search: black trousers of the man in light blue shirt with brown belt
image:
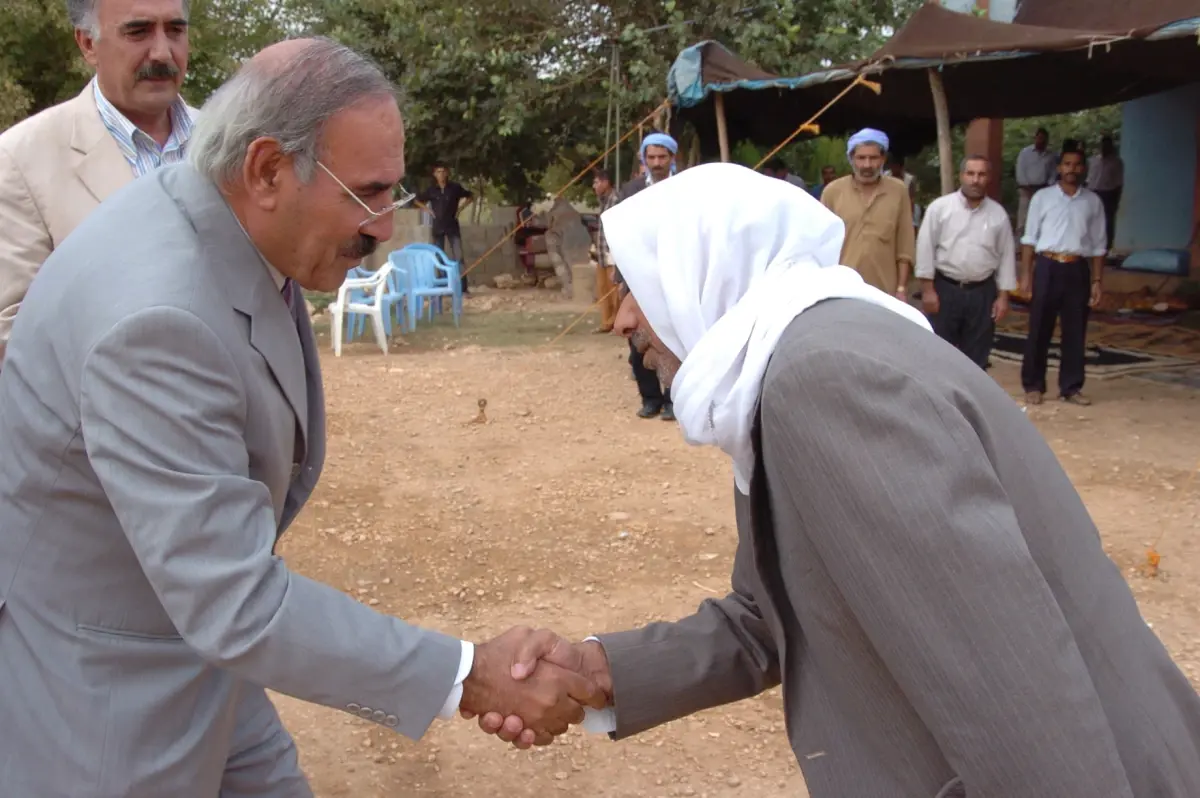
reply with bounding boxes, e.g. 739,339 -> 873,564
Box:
1021,256 -> 1092,396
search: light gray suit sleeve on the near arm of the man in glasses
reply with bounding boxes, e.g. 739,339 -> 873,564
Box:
79,308 -> 462,738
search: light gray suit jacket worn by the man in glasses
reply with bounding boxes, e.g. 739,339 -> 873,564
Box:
0,166 -> 461,798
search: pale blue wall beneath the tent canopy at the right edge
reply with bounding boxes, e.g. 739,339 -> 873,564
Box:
1114,84 -> 1200,256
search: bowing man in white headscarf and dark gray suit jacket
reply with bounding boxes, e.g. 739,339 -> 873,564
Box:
463,164 -> 1200,798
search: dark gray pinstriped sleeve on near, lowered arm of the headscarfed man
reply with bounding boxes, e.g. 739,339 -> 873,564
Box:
762,350 -> 1132,796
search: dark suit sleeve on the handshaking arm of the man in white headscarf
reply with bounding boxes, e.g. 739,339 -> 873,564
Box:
599,504 -> 779,739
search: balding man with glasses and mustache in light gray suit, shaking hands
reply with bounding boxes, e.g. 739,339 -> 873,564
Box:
0,40 -> 604,798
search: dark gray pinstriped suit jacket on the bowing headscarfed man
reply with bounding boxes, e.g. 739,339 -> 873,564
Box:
600,300 -> 1200,798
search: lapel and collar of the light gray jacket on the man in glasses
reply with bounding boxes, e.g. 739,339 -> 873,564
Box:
155,163 -> 311,448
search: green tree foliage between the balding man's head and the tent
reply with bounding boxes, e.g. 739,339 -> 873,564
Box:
312,0 -> 918,202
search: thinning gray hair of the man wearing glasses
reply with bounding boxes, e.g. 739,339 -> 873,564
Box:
187,37 -> 397,184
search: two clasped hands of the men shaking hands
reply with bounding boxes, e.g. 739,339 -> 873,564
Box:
458,626 -> 612,749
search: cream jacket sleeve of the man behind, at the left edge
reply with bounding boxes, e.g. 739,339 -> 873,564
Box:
0,149 -> 52,367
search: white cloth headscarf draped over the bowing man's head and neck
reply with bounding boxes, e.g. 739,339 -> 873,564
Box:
601,163 -> 929,493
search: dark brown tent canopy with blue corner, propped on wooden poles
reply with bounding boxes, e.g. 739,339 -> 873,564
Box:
667,0 -> 1200,157
